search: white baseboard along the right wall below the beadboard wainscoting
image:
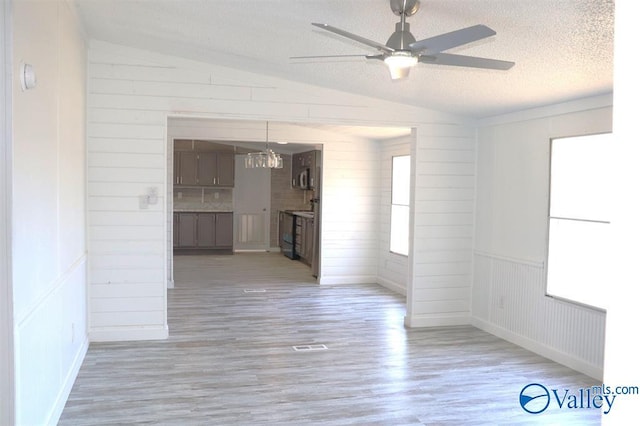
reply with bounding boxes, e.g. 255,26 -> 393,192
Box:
471,317 -> 604,381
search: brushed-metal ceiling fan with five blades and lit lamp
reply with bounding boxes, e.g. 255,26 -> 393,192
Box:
291,0 -> 515,80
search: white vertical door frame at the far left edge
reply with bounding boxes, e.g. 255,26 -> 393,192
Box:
0,0 -> 15,425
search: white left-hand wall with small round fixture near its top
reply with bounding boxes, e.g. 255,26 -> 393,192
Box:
11,0 -> 89,425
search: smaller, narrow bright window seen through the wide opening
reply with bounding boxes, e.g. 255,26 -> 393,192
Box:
389,155 -> 411,256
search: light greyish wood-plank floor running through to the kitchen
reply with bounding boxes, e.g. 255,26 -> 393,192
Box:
60,253 -> 600,425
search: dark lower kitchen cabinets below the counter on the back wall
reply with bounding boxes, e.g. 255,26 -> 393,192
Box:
173,212 -> 233,249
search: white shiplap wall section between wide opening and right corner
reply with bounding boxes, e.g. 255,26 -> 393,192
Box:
406,125 -> 476,326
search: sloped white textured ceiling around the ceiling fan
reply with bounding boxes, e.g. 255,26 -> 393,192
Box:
74,0 -> 614,118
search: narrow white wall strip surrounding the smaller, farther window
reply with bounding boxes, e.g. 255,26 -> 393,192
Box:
377,137 -> 411,295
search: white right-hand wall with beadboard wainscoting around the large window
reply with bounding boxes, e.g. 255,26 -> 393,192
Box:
472,96 -> 612,379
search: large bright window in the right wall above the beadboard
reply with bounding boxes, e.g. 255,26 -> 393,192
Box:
547,133 -> 612,307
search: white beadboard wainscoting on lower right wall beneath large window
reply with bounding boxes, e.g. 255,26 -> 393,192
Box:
473,253 -> 605,379
